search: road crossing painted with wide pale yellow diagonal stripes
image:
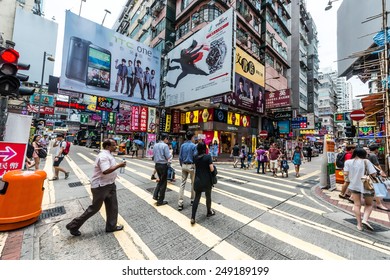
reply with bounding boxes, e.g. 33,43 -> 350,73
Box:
37,147 -> 390,260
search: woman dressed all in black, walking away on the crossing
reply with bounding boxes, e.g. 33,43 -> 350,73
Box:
191,142 -> 215,225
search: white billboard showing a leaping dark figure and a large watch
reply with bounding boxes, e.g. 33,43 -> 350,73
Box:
165,9 -> 235,106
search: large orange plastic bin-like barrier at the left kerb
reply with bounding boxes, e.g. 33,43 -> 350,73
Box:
0,170 -> 47,231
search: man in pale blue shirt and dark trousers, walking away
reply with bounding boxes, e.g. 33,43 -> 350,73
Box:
153,134 -> 170,206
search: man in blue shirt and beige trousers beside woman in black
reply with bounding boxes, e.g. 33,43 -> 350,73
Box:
177,131 -> 196,211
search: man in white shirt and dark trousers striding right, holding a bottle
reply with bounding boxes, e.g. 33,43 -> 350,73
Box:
66,139 -> 126,236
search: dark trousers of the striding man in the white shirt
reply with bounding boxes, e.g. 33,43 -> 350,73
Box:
68,183 -> 118,231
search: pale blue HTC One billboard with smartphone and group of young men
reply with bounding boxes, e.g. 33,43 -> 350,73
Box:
60,11 -> 161,105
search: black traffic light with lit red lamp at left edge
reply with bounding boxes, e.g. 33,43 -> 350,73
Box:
0,47 -> 20,96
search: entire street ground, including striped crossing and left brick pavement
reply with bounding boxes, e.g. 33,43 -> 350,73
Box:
0,146 -> 390,260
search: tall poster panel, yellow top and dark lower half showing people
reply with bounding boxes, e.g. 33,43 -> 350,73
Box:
222,47 -> 265,114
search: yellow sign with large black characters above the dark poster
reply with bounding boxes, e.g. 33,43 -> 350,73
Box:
236,47 -> 264,87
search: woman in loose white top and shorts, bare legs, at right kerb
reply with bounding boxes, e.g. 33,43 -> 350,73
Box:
344,148 -> 376,231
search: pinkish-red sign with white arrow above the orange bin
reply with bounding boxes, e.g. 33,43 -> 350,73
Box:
0,142 -> 27,176
